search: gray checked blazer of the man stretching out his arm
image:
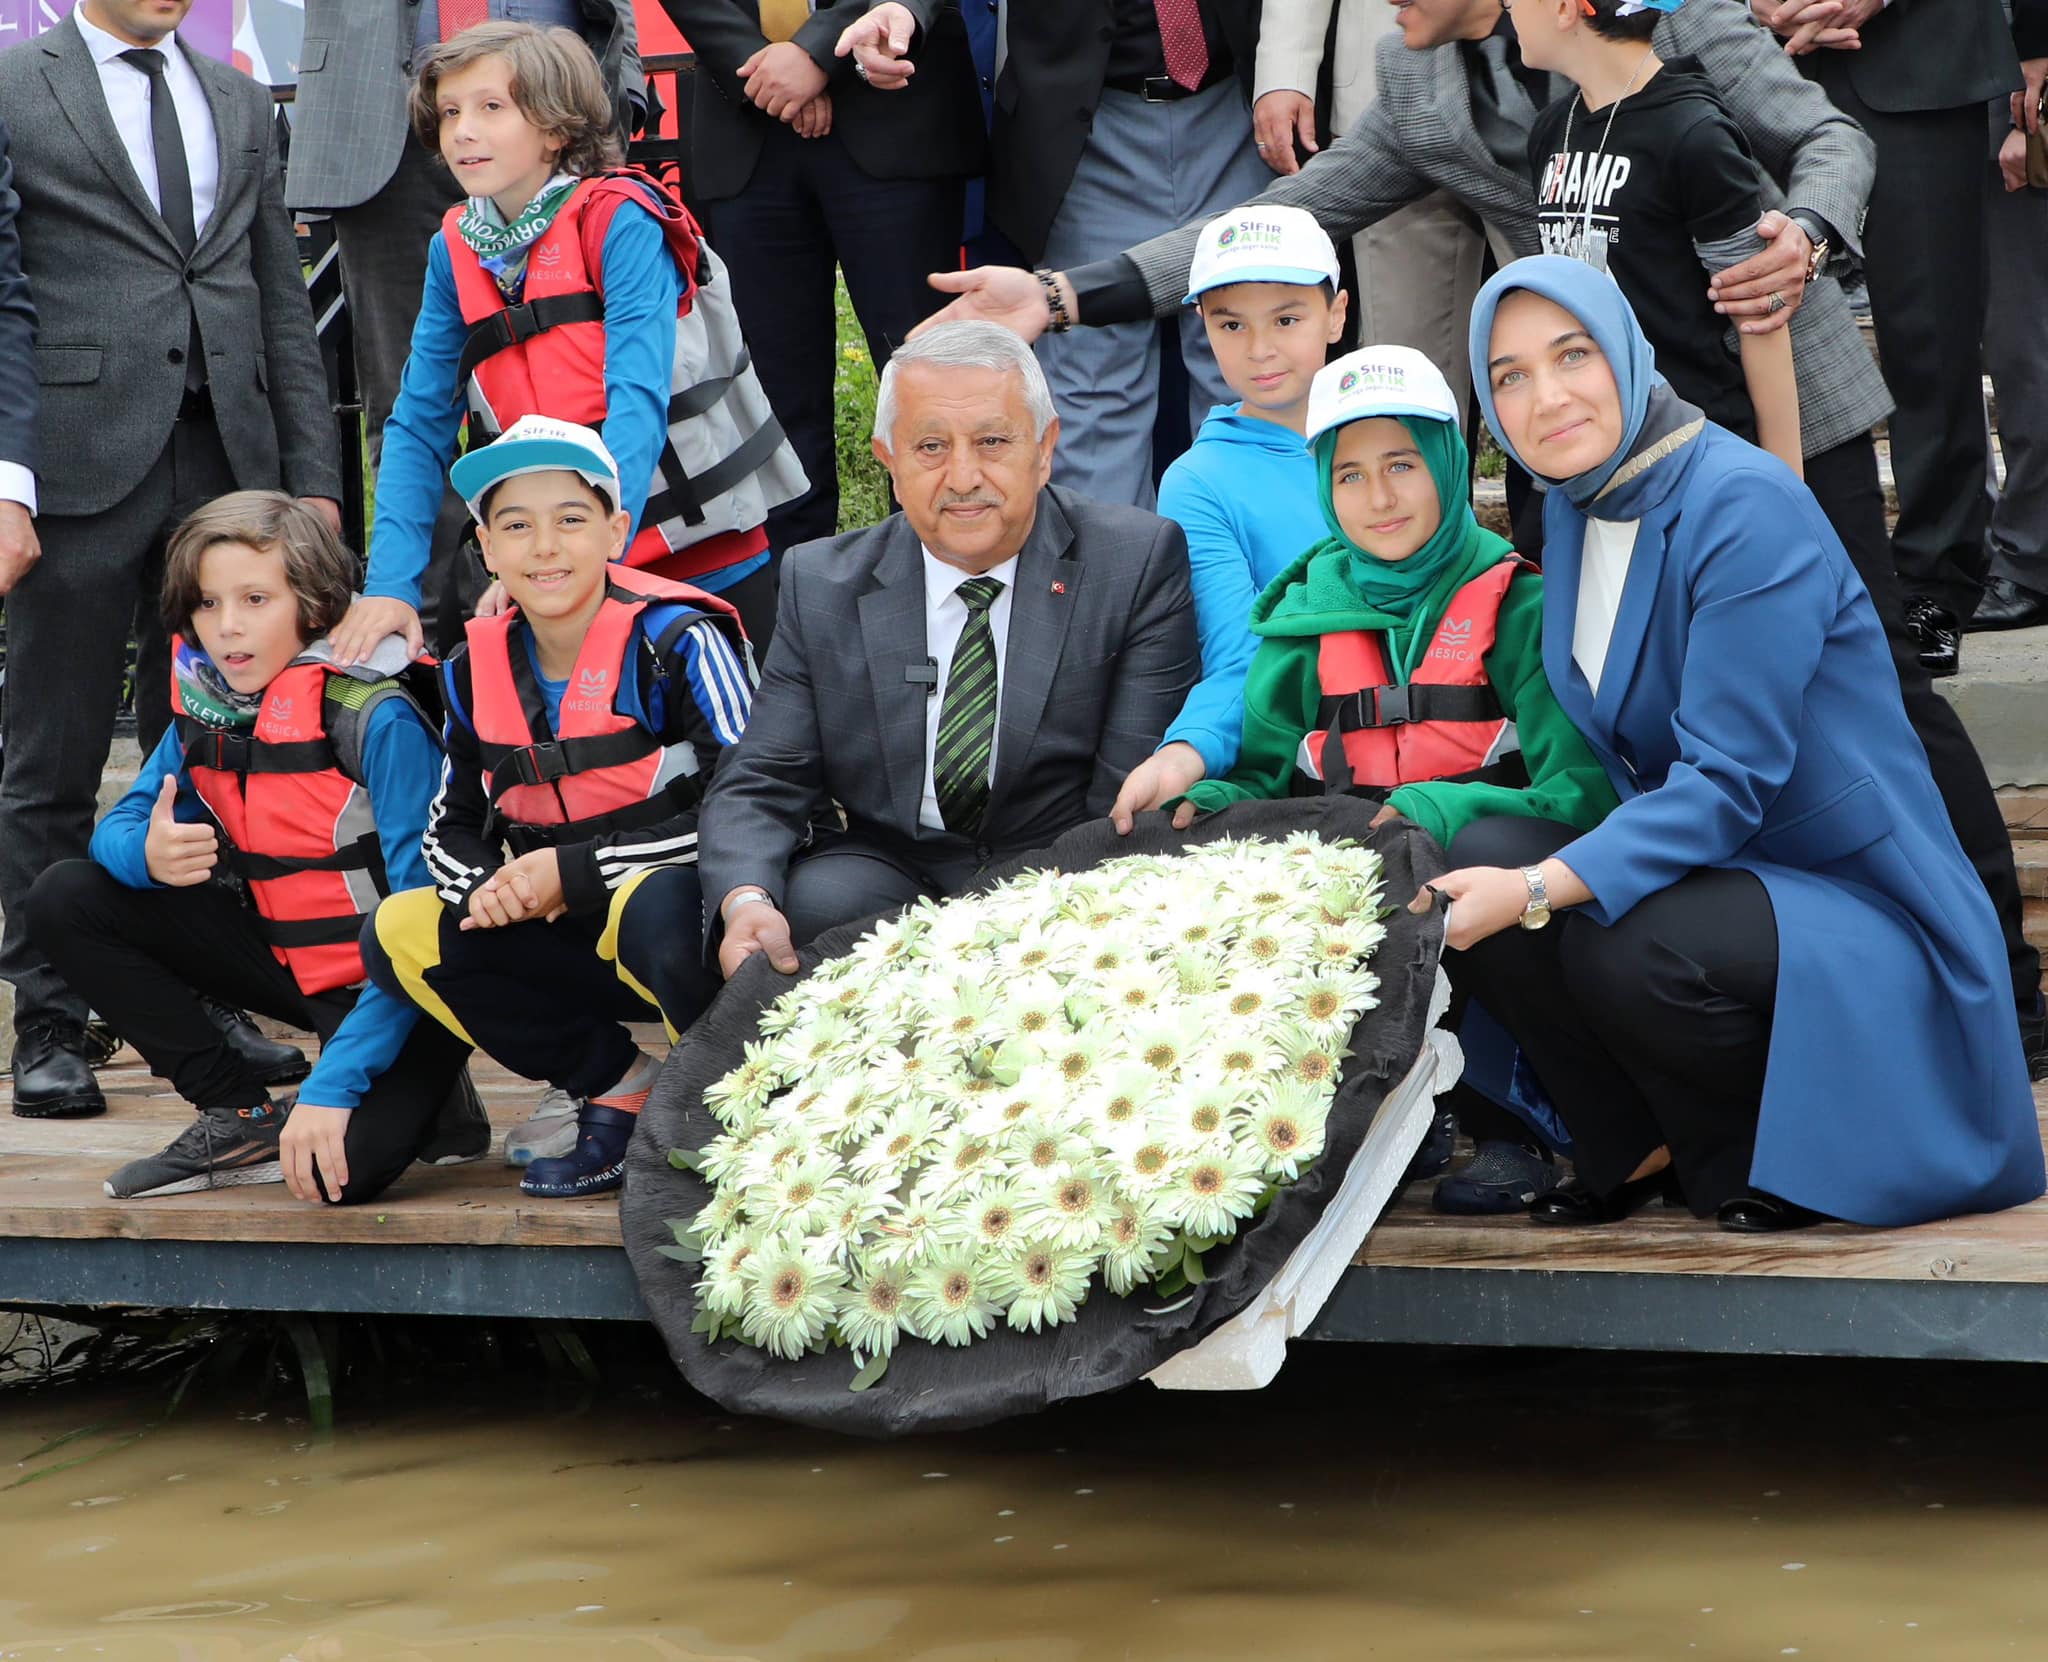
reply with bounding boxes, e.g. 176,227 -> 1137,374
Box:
1122,0 -> 1892,454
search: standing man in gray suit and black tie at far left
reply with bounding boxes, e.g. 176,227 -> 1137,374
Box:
0,0 -> 340,1116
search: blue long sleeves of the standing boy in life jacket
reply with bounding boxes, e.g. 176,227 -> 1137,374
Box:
362,203 -> 684,608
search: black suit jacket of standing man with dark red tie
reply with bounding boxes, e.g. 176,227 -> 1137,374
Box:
995,0 -> 1261,260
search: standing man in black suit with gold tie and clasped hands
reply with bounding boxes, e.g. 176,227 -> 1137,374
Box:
662,0 -> 985,551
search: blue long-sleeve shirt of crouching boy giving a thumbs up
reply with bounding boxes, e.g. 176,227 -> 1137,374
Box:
92,698 -> 440,1107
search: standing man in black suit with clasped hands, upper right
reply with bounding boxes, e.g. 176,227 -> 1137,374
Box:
1751,0 -> 2019,675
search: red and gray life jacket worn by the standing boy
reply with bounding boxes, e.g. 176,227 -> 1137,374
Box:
442,170 -> 809,577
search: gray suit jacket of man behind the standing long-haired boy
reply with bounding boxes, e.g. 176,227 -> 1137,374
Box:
285,0 -> 630,209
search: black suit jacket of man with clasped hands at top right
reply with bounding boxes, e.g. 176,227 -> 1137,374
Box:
1800,0 -> 2019,113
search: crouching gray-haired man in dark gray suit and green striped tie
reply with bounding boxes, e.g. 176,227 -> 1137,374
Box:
696,323 -> 1198,974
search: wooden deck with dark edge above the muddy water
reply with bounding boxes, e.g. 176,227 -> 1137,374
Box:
0,1052 -> 2048,1361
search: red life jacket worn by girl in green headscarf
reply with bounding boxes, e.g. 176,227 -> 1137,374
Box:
1294,559 -> 1532,796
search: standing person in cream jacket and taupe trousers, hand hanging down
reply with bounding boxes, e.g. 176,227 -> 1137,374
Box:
1251,0 -> 1487,418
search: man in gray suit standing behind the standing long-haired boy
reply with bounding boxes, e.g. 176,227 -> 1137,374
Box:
285,0 -> 630,463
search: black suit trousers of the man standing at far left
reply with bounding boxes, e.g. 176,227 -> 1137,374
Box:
0,403 -> 236,1030
